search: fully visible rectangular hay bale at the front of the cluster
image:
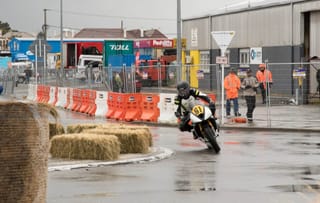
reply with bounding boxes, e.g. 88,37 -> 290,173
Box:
50,133 -> 120,160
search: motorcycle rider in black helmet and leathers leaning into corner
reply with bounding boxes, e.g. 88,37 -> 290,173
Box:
175,81 -> 218,139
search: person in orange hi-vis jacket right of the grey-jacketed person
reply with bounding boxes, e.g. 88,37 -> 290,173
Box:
256,63 -> 273,104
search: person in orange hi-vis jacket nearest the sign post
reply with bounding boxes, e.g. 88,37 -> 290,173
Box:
224,68 -> 241,117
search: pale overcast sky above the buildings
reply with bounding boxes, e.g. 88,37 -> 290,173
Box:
0,0 -> 245,37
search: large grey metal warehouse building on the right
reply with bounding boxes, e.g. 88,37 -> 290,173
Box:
182,0 -> 320,101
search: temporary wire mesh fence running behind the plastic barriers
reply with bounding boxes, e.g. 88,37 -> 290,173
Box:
1,62 -> 320,127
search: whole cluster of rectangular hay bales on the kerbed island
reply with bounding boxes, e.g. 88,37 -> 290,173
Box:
50,124 -> 153,160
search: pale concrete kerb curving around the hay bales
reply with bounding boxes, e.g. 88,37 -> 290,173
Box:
48,147 -> 174,172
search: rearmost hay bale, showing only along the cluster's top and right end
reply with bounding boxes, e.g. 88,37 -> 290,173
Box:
97,124 -> 153,147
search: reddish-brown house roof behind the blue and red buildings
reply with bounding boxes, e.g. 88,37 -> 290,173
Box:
74,28 -> 167,39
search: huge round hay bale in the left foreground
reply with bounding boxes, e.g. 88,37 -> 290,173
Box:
0,100 -> 58,203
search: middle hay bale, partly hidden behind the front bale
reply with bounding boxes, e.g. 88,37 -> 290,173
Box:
84,128 -> 150,154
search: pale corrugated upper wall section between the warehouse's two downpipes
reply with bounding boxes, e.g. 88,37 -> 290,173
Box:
212,6 -> 291,48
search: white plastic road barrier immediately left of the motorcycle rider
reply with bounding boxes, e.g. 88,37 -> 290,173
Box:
158,93 -> 177,124
